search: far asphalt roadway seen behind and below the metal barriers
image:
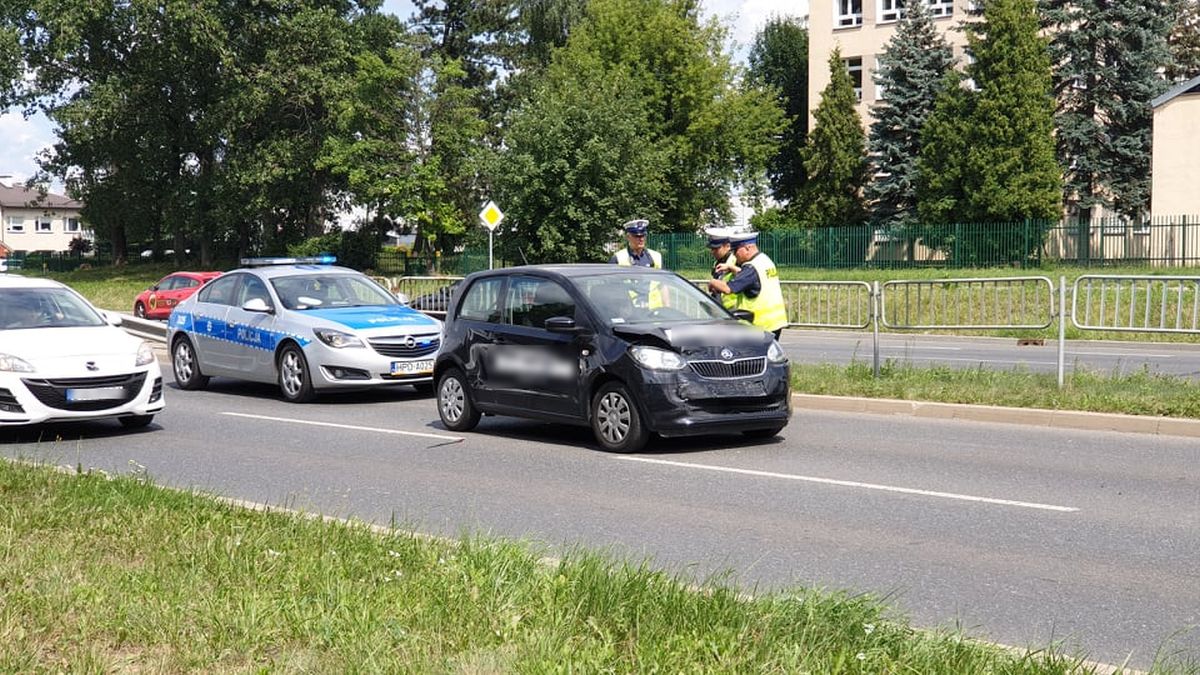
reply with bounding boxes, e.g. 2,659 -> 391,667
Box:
781,329 -> 1200,378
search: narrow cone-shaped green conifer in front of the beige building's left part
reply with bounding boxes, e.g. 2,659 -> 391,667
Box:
803,48 -> 868,226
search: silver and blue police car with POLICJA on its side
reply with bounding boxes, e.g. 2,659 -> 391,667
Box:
167,256 -> 442,402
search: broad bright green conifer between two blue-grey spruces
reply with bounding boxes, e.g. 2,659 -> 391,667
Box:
918,0 -> 1062,222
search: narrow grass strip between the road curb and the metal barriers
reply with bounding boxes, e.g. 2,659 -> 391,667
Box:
792,360 -> 1200,419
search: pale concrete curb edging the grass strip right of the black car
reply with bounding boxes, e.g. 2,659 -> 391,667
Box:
792,394 -> 1200,438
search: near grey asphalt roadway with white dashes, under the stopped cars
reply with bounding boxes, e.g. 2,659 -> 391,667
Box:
0,367 -> 1200,667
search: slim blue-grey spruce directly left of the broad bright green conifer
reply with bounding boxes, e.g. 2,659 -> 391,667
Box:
866,0 -> 954,228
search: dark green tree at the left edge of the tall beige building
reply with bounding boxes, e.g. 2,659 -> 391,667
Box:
749,17 -> 809,204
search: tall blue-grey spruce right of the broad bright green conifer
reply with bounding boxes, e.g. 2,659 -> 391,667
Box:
1042,0 -> 1176,216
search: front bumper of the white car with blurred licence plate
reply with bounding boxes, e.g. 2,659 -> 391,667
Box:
0,364 -> 164,426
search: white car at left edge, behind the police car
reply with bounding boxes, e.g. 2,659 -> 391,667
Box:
0,274 -> 164,428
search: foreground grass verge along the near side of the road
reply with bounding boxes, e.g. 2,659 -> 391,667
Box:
0,461 -> 1180,675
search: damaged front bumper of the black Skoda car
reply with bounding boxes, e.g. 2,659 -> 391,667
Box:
643,364 -> 792,437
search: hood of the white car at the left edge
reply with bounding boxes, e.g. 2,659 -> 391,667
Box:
0,325 -> 142,377
